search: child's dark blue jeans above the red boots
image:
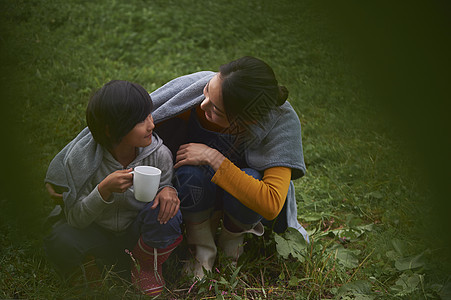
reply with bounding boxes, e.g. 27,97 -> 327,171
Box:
44,202 -> 182,278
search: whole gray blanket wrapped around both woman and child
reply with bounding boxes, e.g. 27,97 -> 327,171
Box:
45,71 -> 308,240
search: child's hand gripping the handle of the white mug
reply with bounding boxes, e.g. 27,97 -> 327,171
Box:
98,169 -> 133,201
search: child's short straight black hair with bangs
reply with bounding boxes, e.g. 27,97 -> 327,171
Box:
86,80 -> 153,149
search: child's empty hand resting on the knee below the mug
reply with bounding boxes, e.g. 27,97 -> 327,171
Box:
150,186 -> 180,224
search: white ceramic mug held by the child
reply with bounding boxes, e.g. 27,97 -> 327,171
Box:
130,166 -> 161,202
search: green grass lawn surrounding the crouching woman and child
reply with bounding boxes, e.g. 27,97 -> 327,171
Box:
0,0 -> 451,299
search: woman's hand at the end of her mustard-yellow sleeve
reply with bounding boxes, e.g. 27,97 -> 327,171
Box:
174,143 -> 225,171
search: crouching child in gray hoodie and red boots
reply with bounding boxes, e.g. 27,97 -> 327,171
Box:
44,80 -> 182,295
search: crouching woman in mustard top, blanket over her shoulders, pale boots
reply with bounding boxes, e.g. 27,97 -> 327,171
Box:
151,57 -> 308,278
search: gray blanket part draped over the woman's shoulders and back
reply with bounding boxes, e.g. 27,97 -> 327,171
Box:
150,71 -> 308,241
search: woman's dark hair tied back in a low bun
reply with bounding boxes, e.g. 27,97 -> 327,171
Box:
219,56 -> 288,122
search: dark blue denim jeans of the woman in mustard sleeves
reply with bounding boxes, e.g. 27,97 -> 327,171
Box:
174,166 -> 263,230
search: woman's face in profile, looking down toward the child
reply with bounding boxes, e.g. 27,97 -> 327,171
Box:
200,73 -> 230,128
